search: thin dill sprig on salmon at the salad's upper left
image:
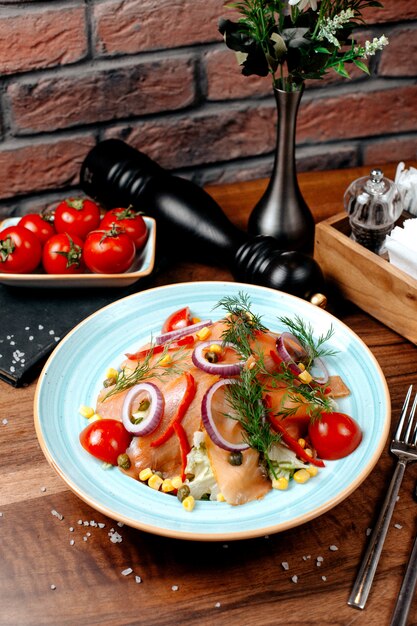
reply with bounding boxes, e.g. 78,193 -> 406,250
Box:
104,344 -> 184,400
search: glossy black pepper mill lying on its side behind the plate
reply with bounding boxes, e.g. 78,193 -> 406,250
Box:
80,139 -> 326,306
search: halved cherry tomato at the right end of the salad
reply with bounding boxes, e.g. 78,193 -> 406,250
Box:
308,412 -> 362,461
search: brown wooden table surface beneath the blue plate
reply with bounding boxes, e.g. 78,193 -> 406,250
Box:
0,167 -> 417,626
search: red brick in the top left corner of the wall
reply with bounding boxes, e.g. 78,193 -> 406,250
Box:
0,6 -> 87,74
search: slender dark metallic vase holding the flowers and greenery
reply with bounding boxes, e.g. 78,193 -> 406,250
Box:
248,89 -> 314,254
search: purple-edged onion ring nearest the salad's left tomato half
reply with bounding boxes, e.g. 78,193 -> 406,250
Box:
122,383 -> 165,436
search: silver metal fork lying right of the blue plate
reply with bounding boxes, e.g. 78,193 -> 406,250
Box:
348,385 -> 417,609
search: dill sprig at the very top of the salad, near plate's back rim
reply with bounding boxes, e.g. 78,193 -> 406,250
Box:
214,291 -> 267,359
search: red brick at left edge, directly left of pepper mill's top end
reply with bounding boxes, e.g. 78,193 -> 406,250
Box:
0,136 -> 95,199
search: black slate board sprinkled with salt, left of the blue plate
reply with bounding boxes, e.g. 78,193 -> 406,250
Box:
0,277 -> 154,387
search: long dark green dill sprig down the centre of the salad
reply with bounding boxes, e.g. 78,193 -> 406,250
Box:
226,367 -> 281,477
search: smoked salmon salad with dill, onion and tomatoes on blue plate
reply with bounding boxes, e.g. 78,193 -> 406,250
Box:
80,292 -> 362,511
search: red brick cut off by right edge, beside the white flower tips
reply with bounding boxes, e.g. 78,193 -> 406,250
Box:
378,26 -> 417,76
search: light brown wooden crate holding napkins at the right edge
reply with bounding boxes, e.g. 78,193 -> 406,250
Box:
315,213 -> 417,344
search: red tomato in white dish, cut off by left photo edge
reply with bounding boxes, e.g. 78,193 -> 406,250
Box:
0,224 -> 42,274
